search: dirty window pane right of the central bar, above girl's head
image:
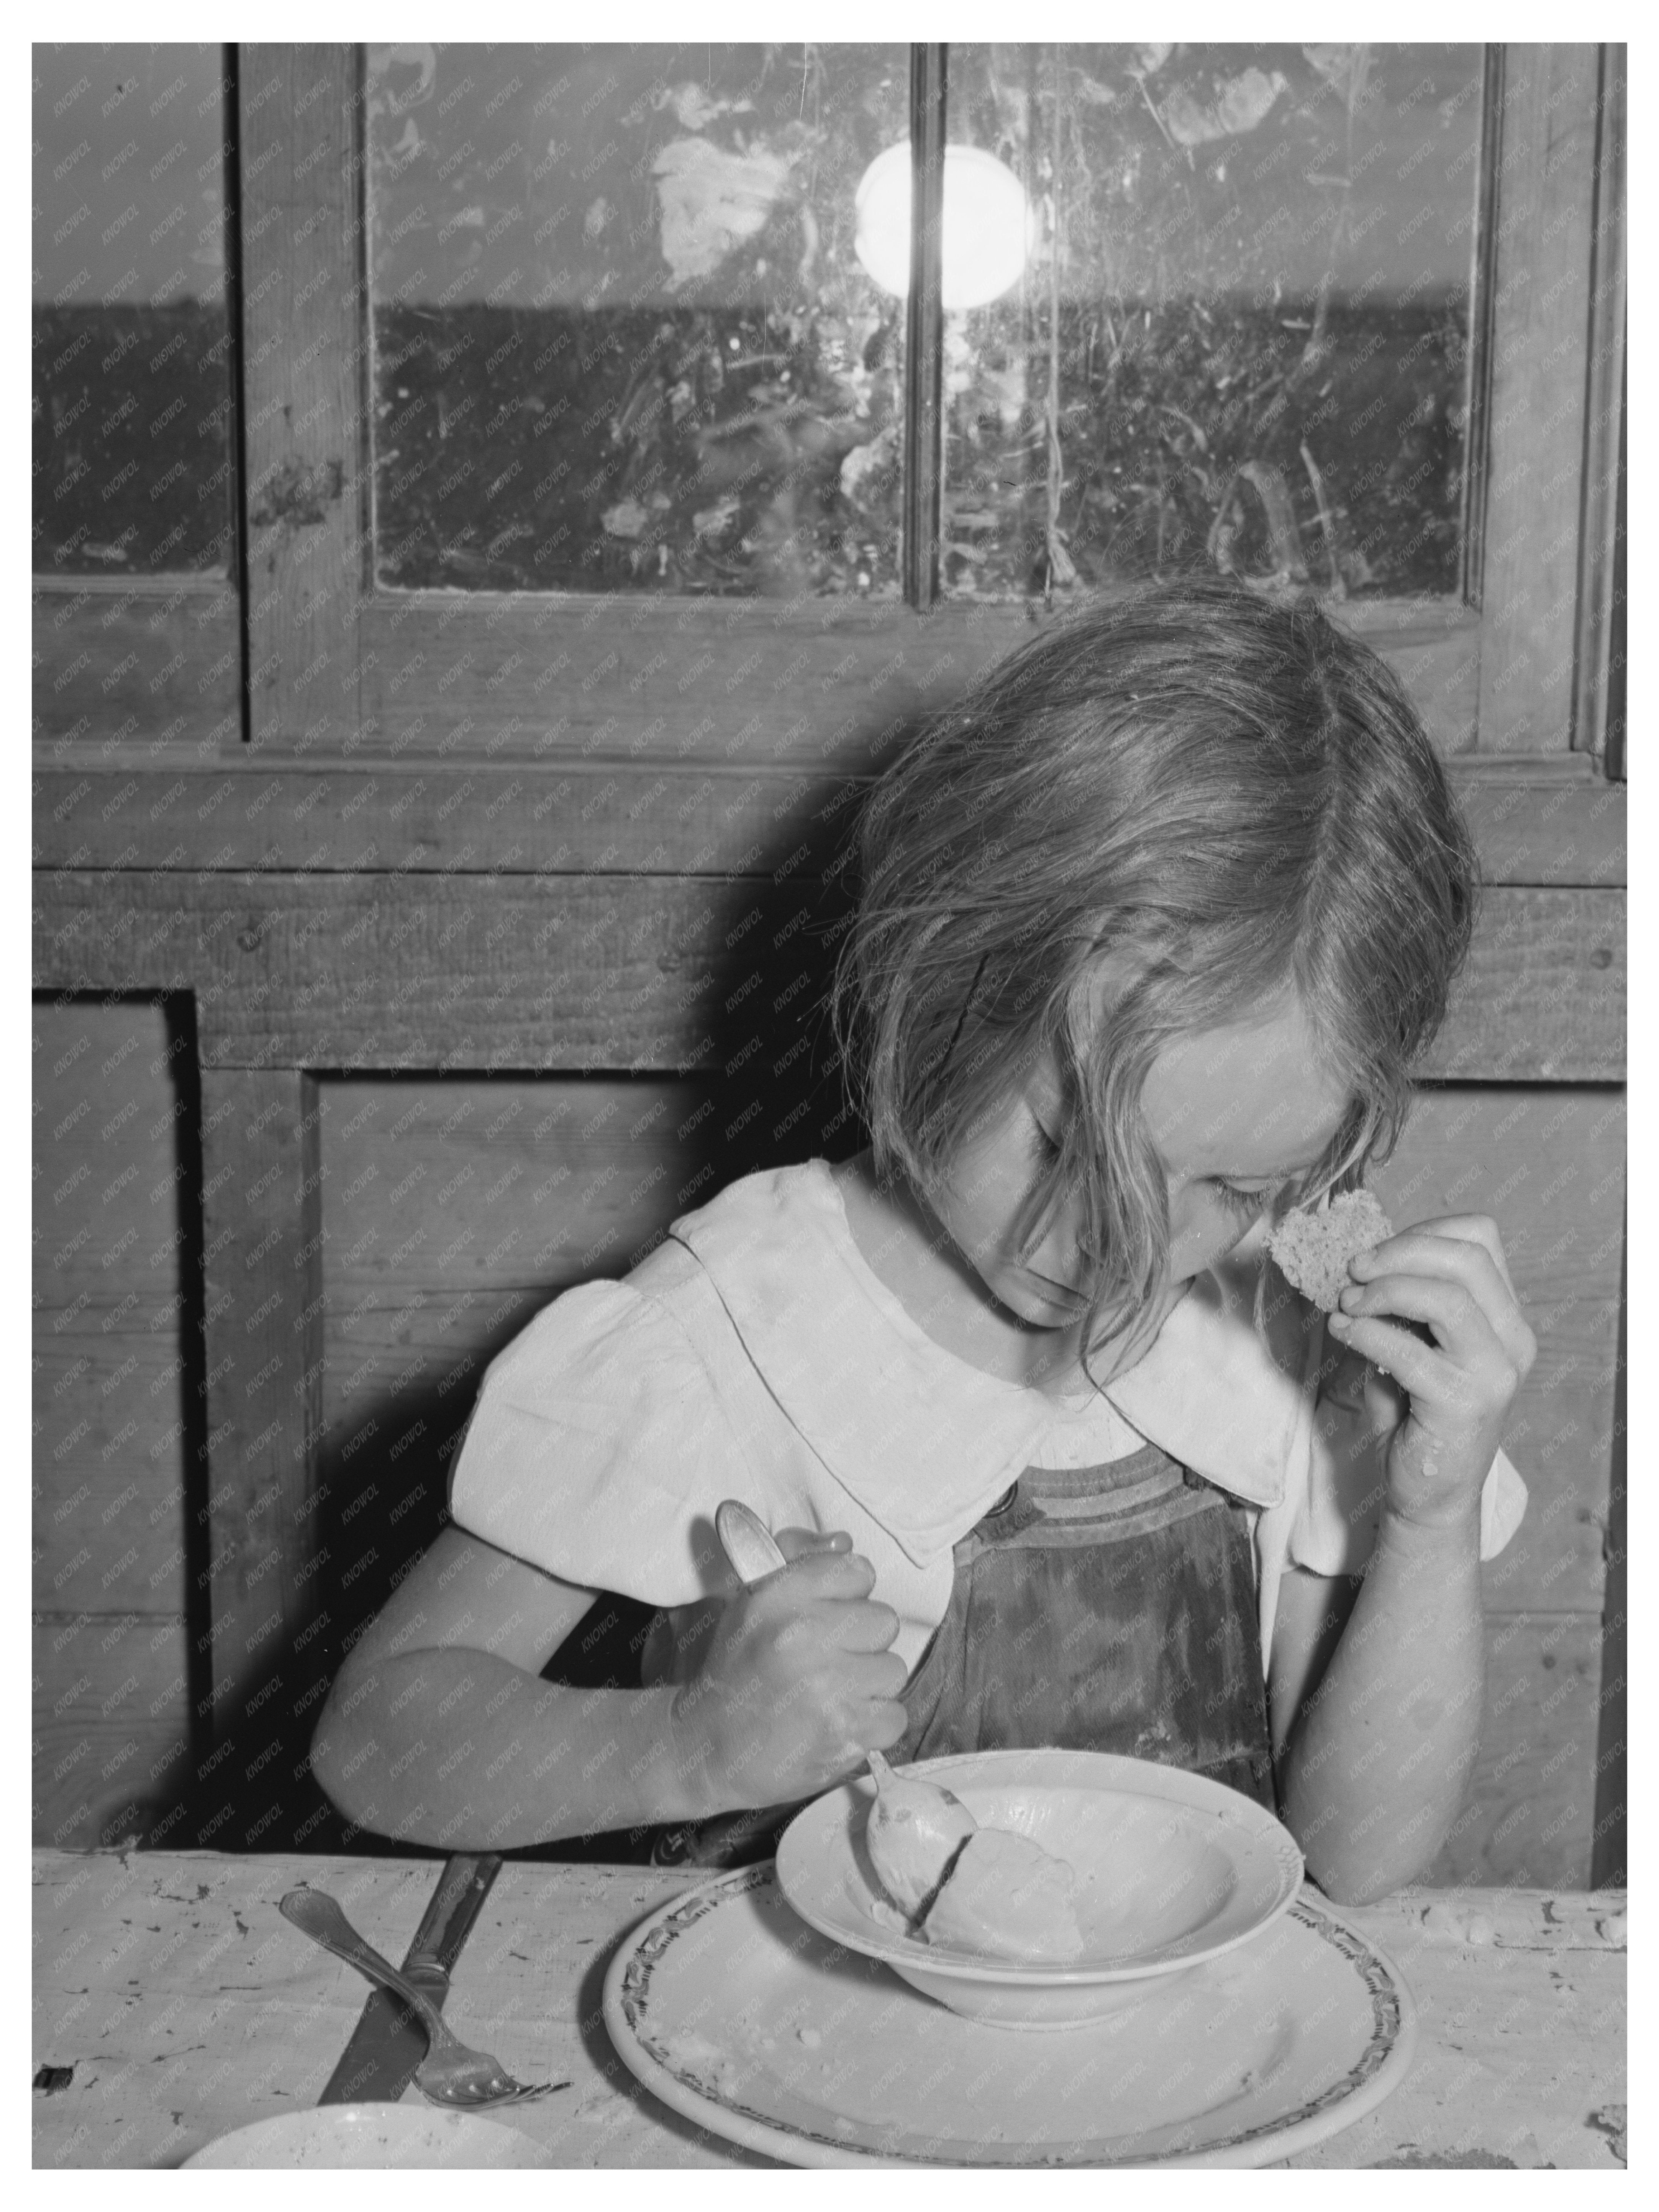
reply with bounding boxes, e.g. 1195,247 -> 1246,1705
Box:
940,44 -> 1482,597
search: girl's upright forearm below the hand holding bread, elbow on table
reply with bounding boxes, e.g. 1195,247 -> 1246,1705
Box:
1281,1511 -> 1487,1905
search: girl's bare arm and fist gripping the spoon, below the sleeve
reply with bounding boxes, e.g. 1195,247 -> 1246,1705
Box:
312,1528 -> 905,1851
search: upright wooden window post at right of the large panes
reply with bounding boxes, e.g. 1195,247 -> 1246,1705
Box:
1478,44 -> 1597,752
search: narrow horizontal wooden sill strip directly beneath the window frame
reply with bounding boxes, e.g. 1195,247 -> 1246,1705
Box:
33,741 -> 1626,887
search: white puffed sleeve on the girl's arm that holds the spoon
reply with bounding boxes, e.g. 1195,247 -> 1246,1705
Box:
449,1281 -> 741,1606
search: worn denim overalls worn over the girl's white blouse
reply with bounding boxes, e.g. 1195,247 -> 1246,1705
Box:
652,1445 -> 1279,1867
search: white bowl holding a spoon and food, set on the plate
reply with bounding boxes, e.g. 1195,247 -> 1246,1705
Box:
776,1748 -> 1303,2028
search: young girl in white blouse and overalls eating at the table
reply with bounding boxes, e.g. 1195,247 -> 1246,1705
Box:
314,584 -> 1535,1900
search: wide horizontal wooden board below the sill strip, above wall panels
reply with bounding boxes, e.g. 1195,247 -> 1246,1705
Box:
35,869 -> 1624,1082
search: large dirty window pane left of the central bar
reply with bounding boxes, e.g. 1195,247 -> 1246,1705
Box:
367,44 -> 909,593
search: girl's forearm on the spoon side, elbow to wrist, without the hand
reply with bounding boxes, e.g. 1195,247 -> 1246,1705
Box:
312,1646 -> 719,1851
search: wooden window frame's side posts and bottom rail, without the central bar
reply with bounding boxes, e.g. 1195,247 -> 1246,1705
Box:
33,44 -> 1624,787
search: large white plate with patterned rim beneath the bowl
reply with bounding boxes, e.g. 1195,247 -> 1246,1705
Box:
604,1865 -> 1413,2166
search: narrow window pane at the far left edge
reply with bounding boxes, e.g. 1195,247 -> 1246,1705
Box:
33,46 -> 234,575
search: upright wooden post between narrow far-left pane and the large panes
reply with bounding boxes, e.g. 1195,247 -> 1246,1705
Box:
239,44 -> 367,750
